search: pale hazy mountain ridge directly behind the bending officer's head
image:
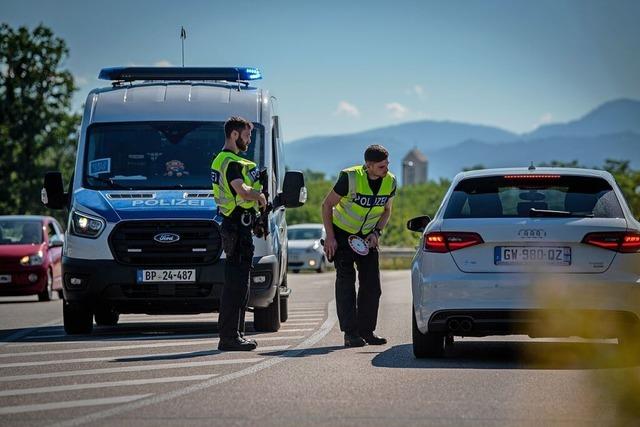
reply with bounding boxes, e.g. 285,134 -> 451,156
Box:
285,120 -> 518,176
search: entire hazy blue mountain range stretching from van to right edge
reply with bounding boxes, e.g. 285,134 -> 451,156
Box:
285,99 -> 640,179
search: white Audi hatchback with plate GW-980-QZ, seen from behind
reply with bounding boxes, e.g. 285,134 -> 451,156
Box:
407,167 -> 640,357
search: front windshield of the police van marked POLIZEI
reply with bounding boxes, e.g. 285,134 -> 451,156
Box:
83,122 -> 264,190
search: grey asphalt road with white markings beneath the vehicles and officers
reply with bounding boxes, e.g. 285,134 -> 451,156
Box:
0,271 -> 640,427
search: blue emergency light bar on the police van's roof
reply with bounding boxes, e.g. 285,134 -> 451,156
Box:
98,67 -> 262,82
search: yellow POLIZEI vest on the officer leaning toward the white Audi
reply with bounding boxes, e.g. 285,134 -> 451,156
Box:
333,165 -> 396,236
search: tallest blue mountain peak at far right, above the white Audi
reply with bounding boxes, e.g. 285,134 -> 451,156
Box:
523,99 -> 640,139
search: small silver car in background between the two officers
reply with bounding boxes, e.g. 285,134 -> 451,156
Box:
287,224 -> 330,273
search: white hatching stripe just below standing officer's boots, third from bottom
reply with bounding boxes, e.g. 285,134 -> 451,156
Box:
0,357 -> 263,382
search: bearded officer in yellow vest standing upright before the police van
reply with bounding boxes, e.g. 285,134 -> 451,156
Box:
211,117 -> 267,351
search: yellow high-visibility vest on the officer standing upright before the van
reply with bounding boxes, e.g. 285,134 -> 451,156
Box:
211,151 -> 262,216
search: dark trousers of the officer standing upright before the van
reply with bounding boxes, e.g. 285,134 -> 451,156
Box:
218,218 -> 254,339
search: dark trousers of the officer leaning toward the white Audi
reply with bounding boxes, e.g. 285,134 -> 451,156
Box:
334,244 -> 382,336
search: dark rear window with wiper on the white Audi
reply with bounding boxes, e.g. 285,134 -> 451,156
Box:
444,175 -> 624,218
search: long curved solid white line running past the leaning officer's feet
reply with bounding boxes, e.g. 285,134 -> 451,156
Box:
52,300 -> 338,427
